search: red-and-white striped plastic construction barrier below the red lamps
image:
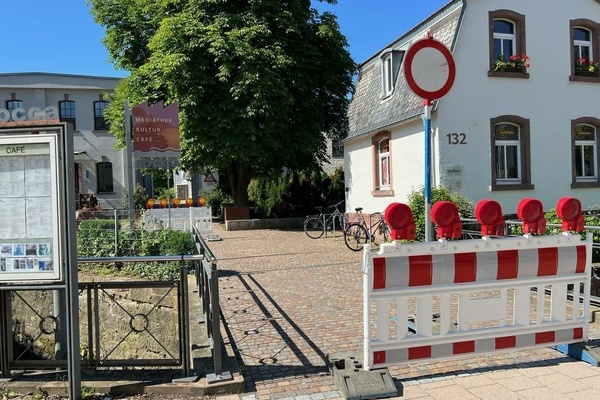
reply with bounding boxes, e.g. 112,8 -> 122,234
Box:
363,198 -> 592,370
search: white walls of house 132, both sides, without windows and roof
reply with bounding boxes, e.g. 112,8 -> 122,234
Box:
344,0 -> 600,214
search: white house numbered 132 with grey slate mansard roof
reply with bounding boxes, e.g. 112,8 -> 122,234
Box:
344,0 -> 600,219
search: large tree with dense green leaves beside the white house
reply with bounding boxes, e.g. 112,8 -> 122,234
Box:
88,0 -> 356,205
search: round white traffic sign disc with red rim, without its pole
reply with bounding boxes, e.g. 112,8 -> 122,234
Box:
404,38 -> 456,101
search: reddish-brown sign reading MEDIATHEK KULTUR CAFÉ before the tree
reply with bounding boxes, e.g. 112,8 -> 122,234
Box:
132,101 -> 180,153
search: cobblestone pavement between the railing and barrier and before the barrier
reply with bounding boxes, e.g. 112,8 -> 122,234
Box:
209,224 -> 600,400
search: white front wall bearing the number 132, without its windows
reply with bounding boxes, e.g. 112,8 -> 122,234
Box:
434,0 -> 600,213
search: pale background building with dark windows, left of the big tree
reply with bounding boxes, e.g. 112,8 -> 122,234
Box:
0,72 -> 218,208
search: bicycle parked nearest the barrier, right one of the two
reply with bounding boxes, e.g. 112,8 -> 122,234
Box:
344,207 -> 390,251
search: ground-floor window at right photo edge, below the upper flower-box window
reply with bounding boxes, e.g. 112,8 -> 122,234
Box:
571,117 -> 600,188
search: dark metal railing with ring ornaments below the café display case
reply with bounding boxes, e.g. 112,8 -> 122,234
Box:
0,228 -> 231,383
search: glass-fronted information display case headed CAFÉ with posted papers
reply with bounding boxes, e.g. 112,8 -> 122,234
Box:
0,132 -> 66,282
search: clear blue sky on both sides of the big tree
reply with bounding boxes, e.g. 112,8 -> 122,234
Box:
0,0 -> 450,77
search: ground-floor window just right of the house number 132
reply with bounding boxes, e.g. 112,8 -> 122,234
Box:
490,115 -> 533,190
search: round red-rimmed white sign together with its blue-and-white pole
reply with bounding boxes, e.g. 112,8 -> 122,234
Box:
404,33 -> 456,241
